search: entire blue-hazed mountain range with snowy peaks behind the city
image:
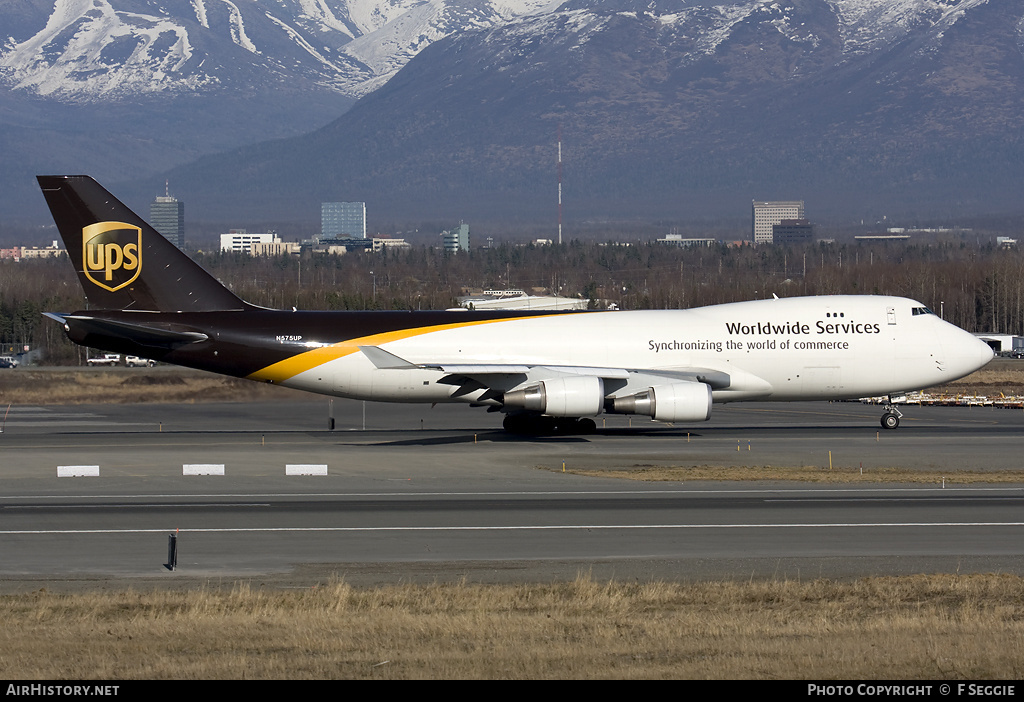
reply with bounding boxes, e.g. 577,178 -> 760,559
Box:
0,0 -> 1024,225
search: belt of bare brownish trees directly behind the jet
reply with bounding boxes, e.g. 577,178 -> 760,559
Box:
0,240 -> 1024,364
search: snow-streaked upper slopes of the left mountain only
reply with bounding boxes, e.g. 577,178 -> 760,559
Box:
0,0 -> 551,101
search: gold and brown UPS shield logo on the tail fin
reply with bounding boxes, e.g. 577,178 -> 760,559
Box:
82,222 -> 142,293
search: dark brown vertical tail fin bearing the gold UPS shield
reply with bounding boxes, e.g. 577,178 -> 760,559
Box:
37,176 -> 247,312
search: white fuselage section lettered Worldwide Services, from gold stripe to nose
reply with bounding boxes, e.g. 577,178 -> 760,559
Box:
283,296 -> 992,413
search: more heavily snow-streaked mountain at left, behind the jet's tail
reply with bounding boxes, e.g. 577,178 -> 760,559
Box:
0,0 -> 557,223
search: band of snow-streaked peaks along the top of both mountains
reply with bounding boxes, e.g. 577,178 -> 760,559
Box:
0,0 -> 988,101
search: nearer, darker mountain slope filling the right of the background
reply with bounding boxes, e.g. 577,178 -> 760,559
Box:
149,0 -> 1024,224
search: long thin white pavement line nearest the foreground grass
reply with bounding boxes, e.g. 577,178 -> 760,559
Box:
0,522 -> 1024,536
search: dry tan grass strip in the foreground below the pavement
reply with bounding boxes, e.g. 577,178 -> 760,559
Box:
0,575 -> 1024,679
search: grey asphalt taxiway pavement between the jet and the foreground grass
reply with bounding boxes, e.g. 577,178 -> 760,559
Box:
0,398 -> 1024,590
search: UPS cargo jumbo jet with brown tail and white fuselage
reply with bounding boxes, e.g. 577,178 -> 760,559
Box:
37,176 -> 993,434
